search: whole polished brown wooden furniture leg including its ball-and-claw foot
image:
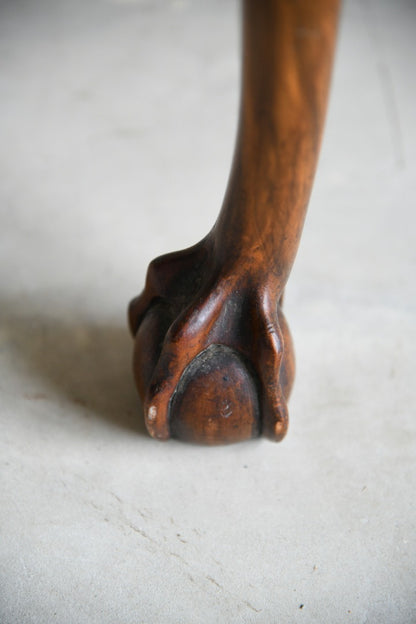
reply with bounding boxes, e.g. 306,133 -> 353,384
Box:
129,0 -> 339,444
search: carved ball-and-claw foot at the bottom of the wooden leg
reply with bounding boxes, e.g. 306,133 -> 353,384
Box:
129,237 -> 294,444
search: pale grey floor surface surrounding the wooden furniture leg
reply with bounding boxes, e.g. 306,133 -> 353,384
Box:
0,0 -> 416,624
